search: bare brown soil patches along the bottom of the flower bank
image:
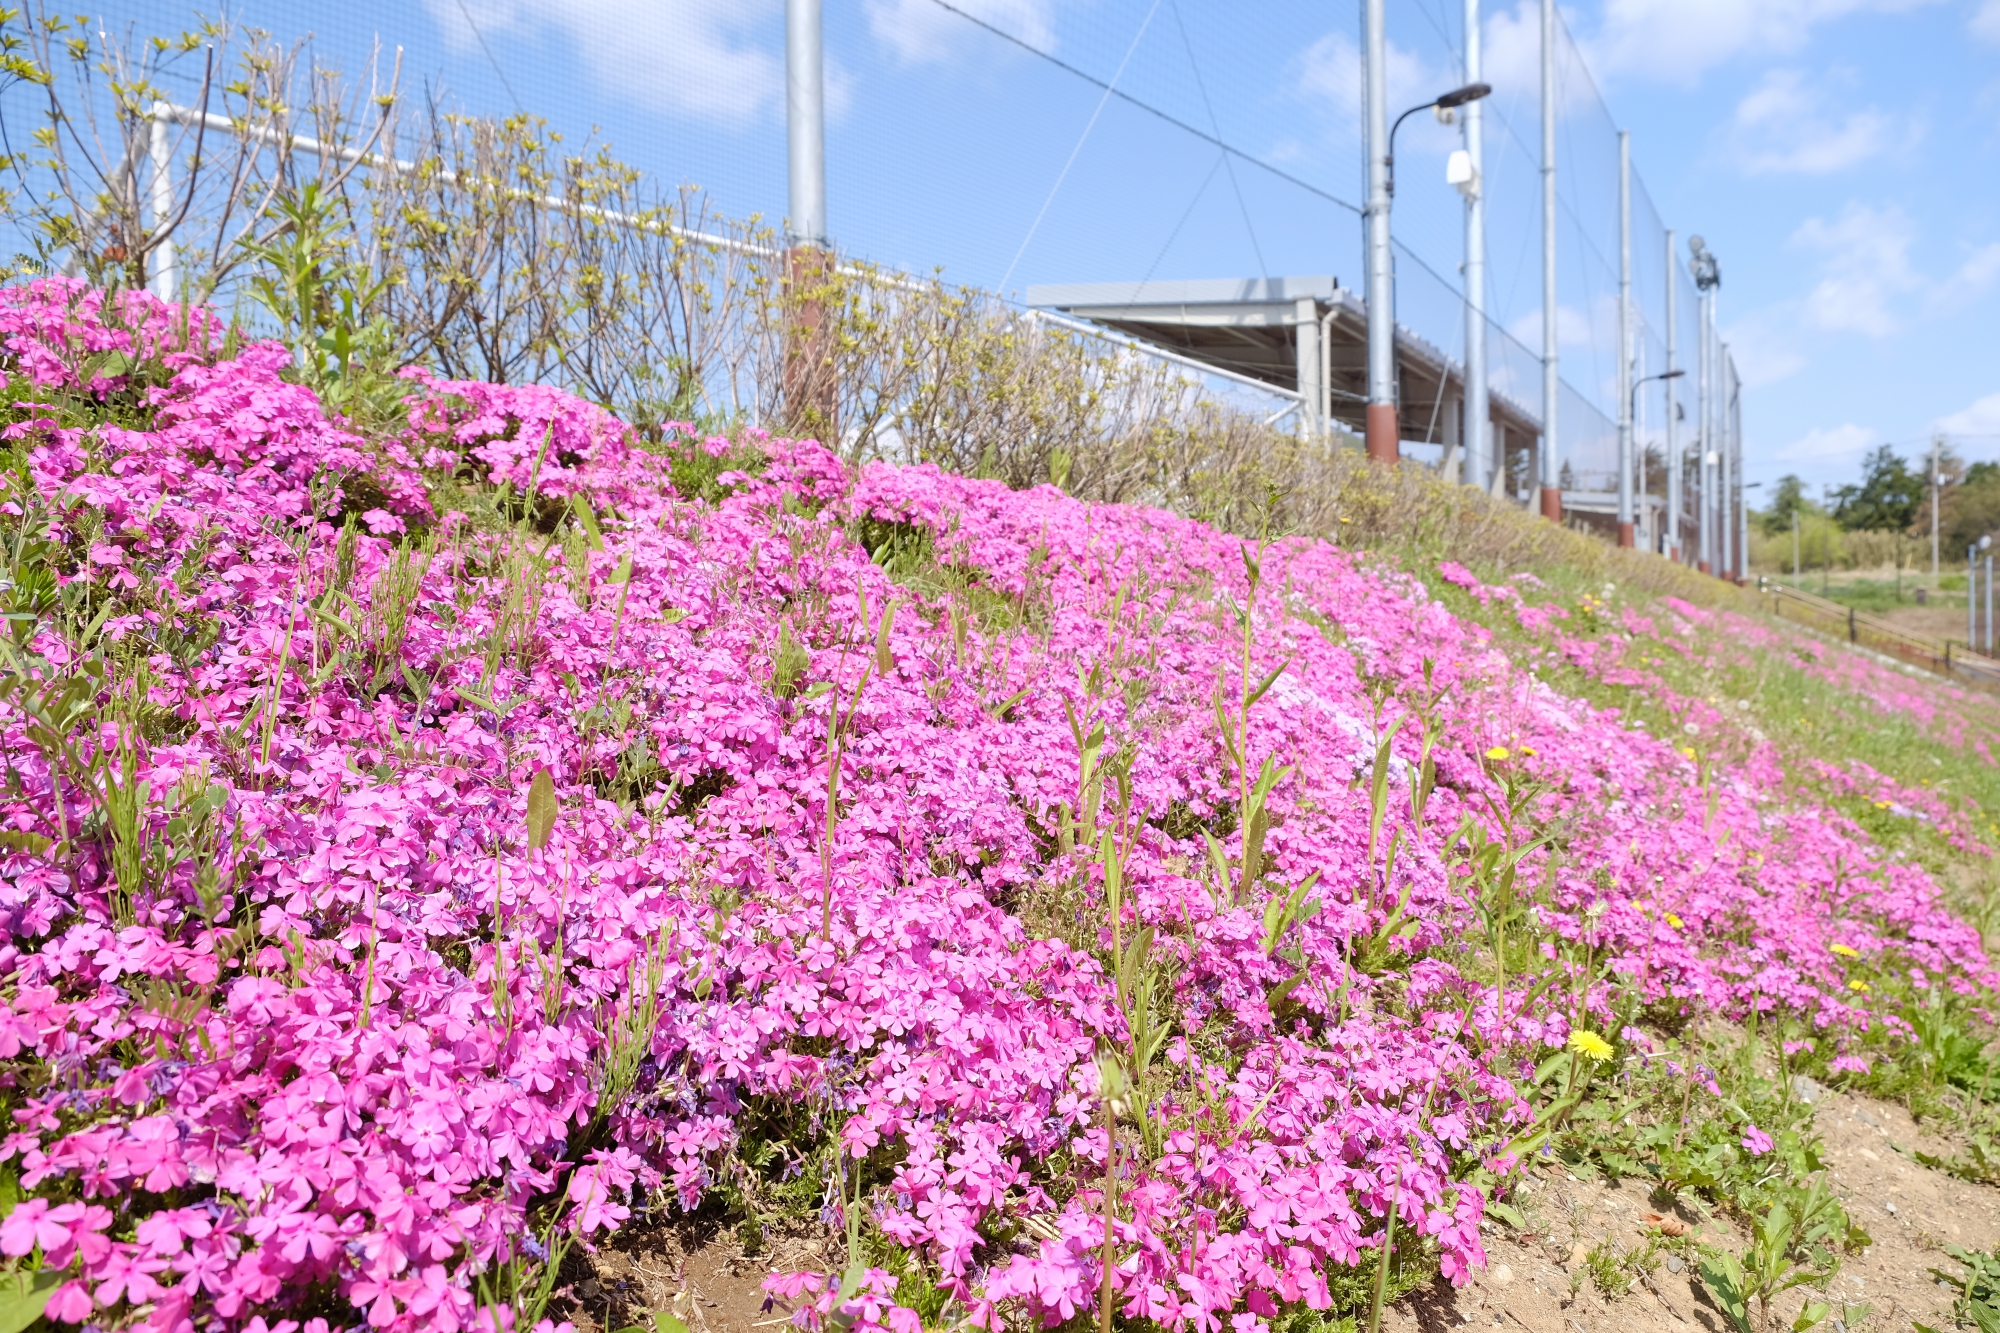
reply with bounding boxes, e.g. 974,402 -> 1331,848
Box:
564,1093 -> 2000,1333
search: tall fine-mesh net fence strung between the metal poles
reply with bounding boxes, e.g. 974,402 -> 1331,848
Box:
0,0 -> 1740,544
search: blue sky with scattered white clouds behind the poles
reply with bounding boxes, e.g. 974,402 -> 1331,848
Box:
122,0 -> 2000,484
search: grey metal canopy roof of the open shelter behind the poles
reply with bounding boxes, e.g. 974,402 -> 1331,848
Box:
1028,276 -> 1542,442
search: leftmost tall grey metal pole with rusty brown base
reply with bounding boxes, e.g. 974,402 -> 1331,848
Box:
784,0 -> 838,442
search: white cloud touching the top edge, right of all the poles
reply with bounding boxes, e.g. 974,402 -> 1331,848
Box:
1580,0 -> 1936,82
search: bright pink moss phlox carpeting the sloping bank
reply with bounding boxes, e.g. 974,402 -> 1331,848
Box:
0,280 -> 1994,1333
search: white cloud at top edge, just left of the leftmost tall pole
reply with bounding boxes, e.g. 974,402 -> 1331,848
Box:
424,0 -> 788,126
